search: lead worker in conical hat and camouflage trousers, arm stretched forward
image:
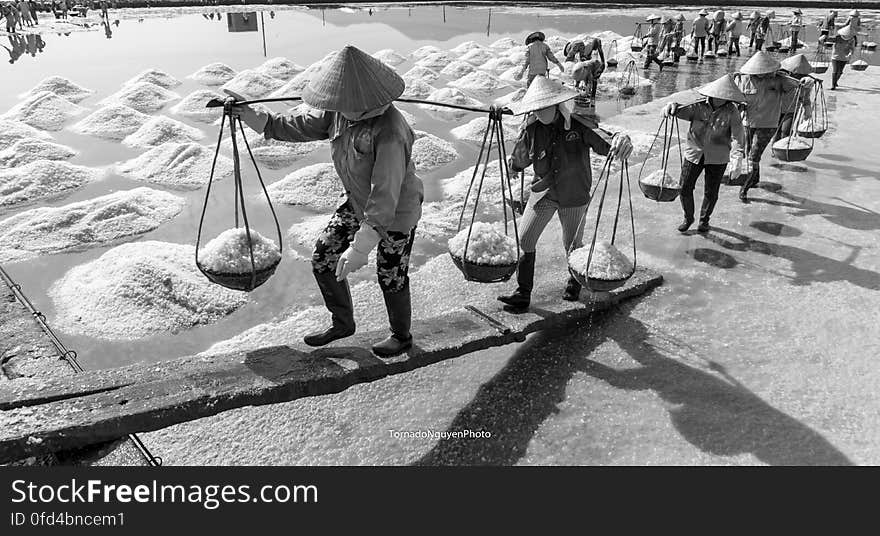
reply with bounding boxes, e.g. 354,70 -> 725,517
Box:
228,46 -> 424,356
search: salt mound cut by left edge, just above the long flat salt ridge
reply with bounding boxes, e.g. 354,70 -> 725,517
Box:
0,160 -> 104,207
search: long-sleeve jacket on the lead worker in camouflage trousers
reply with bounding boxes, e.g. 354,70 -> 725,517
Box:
263,105 -> 424,234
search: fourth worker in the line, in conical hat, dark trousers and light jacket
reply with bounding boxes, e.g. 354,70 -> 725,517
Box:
733,51 -> 801,202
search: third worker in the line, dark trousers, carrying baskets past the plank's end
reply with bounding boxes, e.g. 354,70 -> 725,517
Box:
663,74 -> 745,233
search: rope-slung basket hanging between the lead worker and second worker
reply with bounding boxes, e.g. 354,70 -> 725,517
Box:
449,106 -> 522,283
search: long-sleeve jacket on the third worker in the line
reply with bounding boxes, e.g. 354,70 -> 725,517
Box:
675,99 -> 744,164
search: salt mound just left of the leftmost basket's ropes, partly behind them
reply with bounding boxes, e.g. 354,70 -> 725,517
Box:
116,142 -> 232,189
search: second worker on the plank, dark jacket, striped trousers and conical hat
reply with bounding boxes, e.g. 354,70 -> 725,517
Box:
498,77 -> 632,312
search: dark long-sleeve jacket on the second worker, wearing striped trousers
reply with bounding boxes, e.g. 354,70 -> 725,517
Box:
511,113 -> 611,207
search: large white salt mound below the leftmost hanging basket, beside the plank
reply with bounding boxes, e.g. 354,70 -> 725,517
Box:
49,241 -> 247,340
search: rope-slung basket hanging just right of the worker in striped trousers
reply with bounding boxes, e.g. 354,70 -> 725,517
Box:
568,155 -> 636,292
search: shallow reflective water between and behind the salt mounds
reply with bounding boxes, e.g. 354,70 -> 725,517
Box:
0,6 -> 876,368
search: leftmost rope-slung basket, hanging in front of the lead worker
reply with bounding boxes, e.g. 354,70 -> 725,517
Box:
195,99 -> 283,291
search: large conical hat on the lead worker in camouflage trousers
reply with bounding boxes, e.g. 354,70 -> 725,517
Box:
302,45 -> 406,113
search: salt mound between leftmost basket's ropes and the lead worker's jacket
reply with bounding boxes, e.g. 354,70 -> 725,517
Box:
267,163 -> 342,208
